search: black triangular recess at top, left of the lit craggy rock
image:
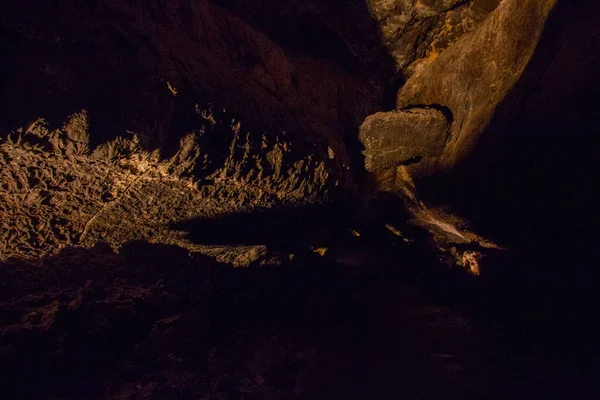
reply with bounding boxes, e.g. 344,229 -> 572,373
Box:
211,0 -> 395,84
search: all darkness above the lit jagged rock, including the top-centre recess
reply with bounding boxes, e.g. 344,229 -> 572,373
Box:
0,0 -> 394,174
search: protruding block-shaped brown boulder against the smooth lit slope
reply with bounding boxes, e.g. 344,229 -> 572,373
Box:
359,108 -> 450,172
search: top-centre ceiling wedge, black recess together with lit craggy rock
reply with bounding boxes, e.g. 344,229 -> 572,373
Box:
214,0 -> 499,85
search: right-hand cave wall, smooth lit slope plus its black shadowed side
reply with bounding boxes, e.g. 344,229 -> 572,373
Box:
366,0 -> 600,262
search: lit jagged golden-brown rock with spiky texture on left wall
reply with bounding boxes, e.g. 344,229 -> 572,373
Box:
0,113 -> 336,259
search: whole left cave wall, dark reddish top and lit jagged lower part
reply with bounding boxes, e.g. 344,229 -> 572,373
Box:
0,0 -> 378,258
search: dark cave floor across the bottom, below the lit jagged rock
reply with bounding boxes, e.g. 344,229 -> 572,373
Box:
0,211 -> 599,399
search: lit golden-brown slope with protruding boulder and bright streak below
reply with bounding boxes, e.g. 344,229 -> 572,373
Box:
360,0 -> 556,266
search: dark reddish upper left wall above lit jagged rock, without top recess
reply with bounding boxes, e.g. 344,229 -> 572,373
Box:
0,0 -> 377,177
